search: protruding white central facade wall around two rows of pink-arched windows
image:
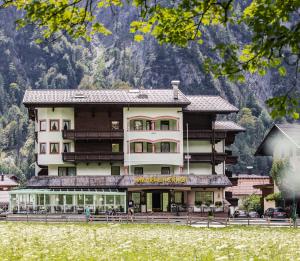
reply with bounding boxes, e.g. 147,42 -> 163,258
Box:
123,107 -> 183,166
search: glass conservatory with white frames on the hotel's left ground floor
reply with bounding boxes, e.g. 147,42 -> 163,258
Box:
9,189 -> 127,214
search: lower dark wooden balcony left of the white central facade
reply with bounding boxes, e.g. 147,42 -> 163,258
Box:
62,151 -> 124,163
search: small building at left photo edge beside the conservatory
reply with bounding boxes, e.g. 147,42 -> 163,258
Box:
0,173 -> 19,210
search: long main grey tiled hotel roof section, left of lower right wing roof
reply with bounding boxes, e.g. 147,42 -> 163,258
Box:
23,89 -> 190,106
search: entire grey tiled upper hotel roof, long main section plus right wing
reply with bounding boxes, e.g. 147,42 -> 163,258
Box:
23,89 -> 238,113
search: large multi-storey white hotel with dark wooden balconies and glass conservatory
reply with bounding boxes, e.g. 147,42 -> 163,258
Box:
10,81 -> 244,213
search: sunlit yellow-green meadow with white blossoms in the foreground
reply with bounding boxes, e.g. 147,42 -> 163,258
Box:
0,222 -> 300,261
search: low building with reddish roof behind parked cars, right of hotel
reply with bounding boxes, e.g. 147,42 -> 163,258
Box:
226,174 -> 272,206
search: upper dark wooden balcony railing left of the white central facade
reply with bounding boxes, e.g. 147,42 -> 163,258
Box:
62,130 -> 124,140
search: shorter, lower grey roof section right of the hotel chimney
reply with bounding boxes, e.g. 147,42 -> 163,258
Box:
185,95 -> 239,113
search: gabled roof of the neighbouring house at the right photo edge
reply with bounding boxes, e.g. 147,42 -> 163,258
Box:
255,123 -> 300,156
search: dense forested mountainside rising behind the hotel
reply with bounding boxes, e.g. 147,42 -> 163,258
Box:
0,6 -> 289,180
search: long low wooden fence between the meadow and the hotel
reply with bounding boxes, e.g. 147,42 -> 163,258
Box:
0,214 -> 299,227
